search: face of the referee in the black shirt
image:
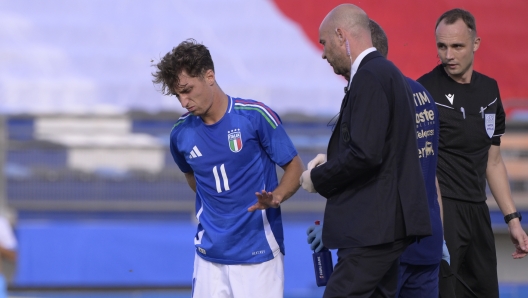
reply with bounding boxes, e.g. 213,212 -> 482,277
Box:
436,19 -> 480,83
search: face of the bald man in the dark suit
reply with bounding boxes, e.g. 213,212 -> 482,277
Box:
319,21 -> 350,77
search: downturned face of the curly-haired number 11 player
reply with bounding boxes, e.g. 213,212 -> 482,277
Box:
174,70 -> 214,116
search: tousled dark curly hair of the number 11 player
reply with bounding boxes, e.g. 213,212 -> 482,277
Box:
152,38 -> 214,95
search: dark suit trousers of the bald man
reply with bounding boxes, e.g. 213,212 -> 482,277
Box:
323,237 -> 415,298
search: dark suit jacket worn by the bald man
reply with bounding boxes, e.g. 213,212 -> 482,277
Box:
311,52 -> 431,248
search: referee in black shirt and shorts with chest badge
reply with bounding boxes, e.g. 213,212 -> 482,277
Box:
418,9 -> 528,297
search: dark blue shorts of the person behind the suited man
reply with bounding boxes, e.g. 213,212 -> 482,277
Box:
396,263 -> 440,298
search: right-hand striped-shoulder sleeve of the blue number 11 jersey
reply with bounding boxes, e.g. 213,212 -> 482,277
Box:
253,103 -> 297,167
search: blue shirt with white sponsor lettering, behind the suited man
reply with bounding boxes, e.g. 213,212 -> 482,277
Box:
400,78 -> 443,265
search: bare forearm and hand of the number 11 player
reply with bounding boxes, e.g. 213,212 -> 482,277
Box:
248,155 -> 304,212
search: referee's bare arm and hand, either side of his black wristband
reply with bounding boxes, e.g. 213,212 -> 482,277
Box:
486,145 -> 528,259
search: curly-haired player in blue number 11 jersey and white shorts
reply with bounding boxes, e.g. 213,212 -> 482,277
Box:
153,39 -> 303,298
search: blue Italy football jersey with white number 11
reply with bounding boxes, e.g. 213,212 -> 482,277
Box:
170,96 -> 297,264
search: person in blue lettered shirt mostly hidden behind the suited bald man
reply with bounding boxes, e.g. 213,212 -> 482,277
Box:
307,20 -> 448,298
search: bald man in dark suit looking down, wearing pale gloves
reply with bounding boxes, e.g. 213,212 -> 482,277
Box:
301,4 -> 431,297
